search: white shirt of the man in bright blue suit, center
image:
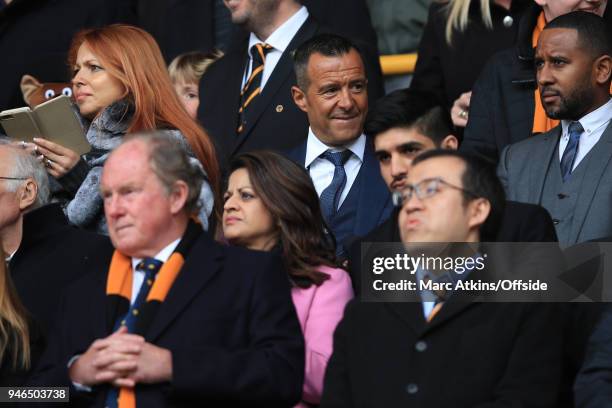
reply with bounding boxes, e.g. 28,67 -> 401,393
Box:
304,128 -> 366,210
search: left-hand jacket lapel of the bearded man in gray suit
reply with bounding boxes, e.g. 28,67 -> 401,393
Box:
527,126 -> 561,204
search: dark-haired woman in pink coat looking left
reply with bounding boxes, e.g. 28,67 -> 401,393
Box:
223,152 -> 353,406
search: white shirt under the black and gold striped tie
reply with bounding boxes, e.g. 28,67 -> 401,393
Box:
242,6 -> 308,90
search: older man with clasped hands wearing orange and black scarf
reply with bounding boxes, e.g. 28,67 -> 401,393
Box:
32,135 -> 304,408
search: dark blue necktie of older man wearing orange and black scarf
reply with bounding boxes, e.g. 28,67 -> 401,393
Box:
104,258 -> 163,408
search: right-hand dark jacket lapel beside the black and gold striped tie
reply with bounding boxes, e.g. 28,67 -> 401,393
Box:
231,17 -> 319,155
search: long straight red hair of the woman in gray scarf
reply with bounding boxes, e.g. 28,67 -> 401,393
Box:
68,24 -> 221,199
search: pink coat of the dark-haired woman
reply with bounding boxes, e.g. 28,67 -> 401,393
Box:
291,266 -> 353,407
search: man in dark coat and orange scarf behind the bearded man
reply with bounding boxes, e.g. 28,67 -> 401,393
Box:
461,0 -> 612,164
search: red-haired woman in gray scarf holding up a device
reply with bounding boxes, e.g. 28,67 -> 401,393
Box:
29,24 -> 220,232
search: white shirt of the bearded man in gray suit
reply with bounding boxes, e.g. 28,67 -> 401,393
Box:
559,99 -> 612,171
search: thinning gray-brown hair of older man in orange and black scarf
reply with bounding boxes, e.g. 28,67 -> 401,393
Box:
123,132 -> 205,215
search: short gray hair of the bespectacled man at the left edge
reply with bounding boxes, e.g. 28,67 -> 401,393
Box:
0,138 -> 51,210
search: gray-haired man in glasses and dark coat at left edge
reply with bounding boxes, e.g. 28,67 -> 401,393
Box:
0,140 -> 112,336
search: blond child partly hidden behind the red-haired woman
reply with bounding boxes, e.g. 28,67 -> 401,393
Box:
168,50 -> 223,119
